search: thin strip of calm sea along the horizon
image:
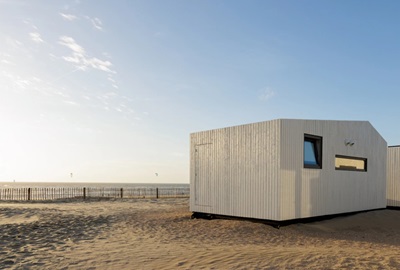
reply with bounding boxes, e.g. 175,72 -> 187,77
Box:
0,182 -> 189,188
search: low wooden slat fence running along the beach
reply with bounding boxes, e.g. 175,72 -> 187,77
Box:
0,187 -> 190,201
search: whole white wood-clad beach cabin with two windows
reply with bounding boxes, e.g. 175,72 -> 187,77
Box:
190,119 -> 387,221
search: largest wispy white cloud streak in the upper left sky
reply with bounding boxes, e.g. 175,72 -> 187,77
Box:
59,36 -> 116,73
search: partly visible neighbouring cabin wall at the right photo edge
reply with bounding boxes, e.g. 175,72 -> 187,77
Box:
386,146 -> 400,207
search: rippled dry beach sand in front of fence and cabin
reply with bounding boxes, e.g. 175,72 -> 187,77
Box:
0,199 -> 400,269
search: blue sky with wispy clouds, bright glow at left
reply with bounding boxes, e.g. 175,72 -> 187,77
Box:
0,0 -> 400,183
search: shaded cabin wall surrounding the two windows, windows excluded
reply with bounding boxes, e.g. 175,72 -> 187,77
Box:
280,120 -> 387,220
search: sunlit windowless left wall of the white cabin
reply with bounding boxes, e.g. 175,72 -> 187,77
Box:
190,120 -> 280,220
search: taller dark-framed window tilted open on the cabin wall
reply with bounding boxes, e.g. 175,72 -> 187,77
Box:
304,134 -> 322,169
